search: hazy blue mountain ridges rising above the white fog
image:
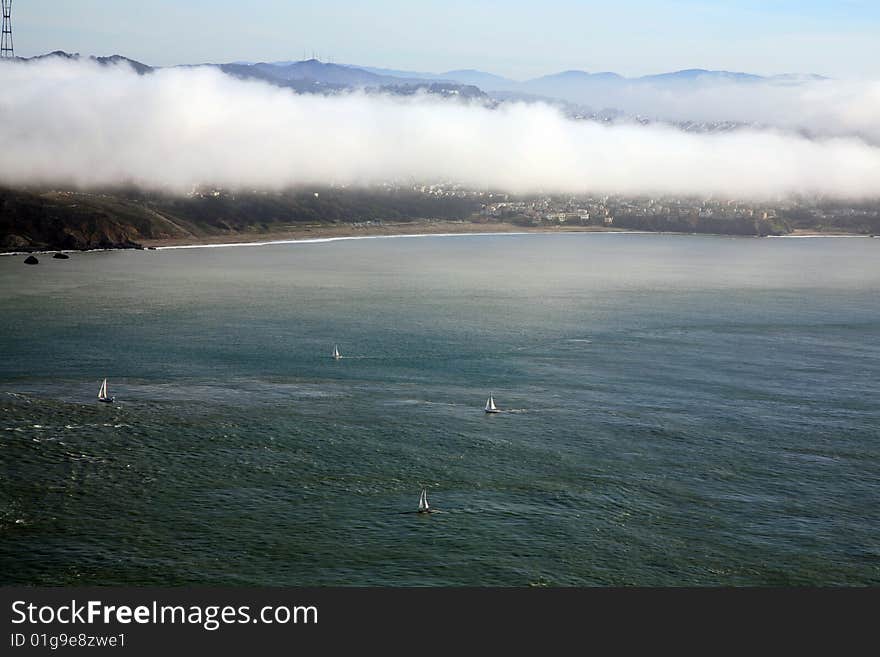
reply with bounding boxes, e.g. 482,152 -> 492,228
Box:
17,50 -> 840,132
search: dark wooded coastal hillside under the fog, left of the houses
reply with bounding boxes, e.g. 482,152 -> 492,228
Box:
0,189 -> 480,251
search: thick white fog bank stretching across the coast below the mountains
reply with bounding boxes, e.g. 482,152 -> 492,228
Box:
0,60 -> 880,199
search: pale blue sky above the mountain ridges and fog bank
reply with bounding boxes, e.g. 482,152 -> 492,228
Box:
13,0 -> 880,79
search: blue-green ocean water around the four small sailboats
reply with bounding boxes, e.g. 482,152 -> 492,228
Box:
0,234 -> 880,586
